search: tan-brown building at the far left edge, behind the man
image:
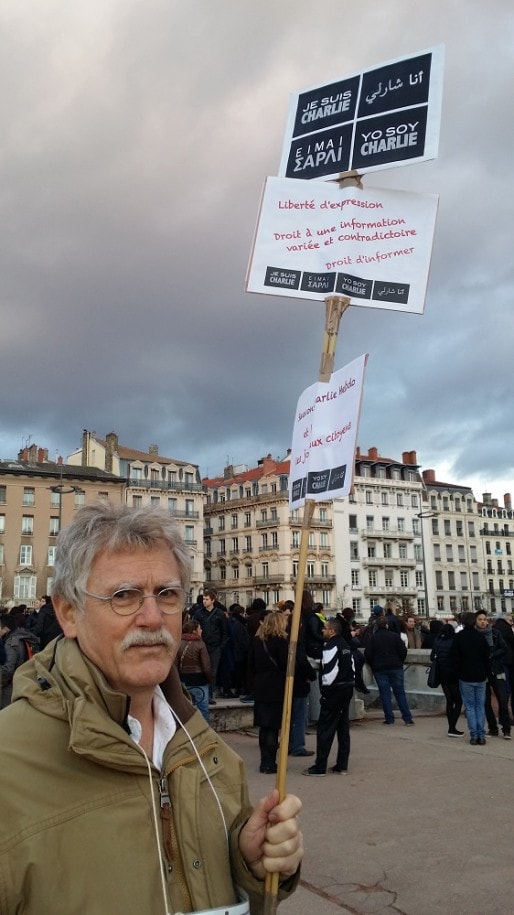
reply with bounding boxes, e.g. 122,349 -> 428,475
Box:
0,445 -> 125,606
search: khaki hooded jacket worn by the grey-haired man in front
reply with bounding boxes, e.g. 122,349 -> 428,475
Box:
0,639 -> 295,915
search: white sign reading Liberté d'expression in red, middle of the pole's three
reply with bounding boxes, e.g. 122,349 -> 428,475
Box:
246,178 -> 439,314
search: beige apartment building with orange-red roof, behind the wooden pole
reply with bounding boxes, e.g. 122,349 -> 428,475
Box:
203,454 -> 335,607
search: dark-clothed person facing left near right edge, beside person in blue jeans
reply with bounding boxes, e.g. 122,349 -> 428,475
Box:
475,611 -> 512,740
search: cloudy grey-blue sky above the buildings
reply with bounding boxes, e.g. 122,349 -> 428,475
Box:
0,0 -> 514,499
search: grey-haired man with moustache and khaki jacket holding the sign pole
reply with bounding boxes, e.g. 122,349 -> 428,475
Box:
0,500 -> 302,915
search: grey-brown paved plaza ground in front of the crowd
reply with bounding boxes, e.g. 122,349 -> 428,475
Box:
223,711 -> 514,915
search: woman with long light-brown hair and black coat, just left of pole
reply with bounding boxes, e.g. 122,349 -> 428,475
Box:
251,610 -> 288,774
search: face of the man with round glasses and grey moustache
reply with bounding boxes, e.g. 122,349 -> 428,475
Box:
56,545 -> 182,696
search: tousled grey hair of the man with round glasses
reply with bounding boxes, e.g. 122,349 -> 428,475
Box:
52,499 -> 191,609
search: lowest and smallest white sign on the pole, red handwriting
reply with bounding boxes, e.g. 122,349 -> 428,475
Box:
289,354 -> 368,510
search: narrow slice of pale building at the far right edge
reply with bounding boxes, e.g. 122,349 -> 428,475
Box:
478,493 -> 514,613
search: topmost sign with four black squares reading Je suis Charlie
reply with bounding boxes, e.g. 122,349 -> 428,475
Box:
279,45 -> 444,179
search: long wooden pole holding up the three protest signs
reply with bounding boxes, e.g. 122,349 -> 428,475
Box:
263,295 -> 350,915
